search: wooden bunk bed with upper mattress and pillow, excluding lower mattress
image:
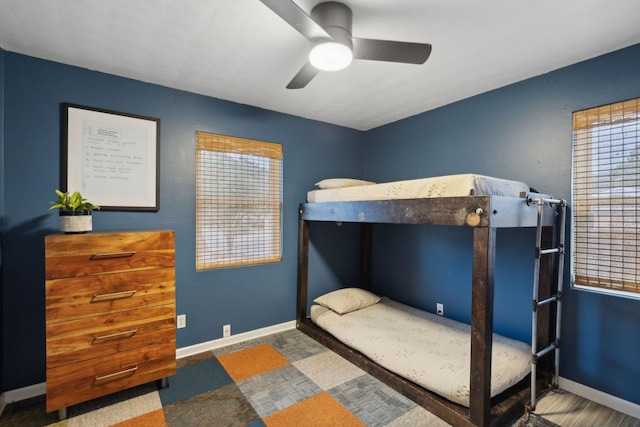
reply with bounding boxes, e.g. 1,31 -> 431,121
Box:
296,174 -> 564,426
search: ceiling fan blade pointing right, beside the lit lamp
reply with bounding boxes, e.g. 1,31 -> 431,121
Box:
351,37 -> 431,64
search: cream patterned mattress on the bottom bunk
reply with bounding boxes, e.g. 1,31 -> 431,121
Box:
311,290 -> 531,407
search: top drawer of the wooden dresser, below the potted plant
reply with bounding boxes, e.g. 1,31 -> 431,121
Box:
45,231 -> 175,280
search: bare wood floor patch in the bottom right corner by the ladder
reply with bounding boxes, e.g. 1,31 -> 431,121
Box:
534,390 -> 640,427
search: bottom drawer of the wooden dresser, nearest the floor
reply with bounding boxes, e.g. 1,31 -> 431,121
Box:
47,343 -> 176,412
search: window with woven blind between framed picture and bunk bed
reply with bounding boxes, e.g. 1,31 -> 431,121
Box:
196,132 -> 282,270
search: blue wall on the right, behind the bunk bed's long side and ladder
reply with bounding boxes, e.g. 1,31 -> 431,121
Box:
365,45 -> 640,404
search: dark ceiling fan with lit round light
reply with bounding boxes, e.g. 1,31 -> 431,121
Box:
260,0 -> 431,89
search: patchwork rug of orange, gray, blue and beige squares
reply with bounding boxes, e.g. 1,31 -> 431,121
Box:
0,330 -> 552,427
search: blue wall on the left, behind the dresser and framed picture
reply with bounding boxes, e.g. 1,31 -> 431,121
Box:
2,52 -> 363,390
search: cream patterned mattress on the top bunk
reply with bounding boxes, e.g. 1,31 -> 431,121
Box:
307,174 -> 529,203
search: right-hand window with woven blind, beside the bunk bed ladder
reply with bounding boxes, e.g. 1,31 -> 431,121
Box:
572,99 -> 640,298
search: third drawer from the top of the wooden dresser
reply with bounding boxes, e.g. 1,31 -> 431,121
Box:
46,304 -> 176,369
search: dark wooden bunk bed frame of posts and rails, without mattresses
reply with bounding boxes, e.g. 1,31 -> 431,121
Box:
296,193 -> 557,426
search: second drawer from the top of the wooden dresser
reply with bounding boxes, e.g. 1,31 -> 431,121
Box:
45,268 -> 175,323
